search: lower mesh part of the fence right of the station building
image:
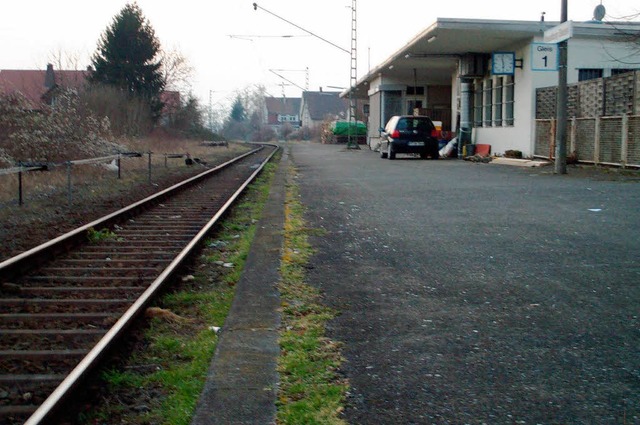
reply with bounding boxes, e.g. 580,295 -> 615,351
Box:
534,115 -> 640,167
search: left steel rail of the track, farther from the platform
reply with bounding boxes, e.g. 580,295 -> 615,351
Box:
0,145 -> 264,282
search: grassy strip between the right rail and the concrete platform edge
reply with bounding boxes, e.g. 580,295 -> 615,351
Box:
81,160 -> 277,425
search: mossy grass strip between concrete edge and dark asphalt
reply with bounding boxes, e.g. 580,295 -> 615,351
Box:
277,168 -> 349,425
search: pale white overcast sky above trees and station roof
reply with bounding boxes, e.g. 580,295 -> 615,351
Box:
0,0 -> 640,109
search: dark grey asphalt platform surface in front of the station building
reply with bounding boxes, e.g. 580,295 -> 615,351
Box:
290,143 -> 640,424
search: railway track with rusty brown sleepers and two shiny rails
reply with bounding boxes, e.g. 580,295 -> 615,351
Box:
0,146 -> 276,424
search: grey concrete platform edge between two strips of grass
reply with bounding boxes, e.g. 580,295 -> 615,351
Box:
191,149 -> 288,425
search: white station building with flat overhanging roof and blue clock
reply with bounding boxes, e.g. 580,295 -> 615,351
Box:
342,18 -> 640,156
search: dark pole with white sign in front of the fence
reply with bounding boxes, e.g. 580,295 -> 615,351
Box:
554,0 -> 568,174
